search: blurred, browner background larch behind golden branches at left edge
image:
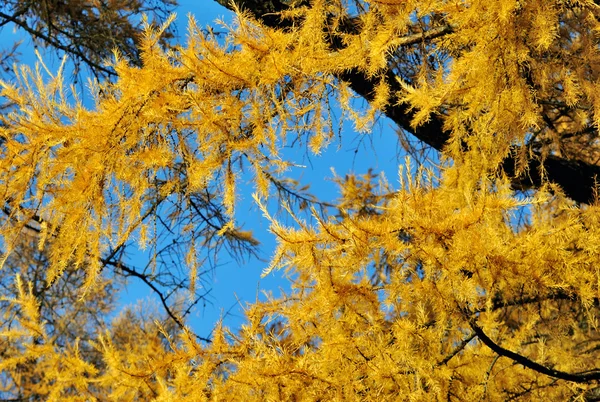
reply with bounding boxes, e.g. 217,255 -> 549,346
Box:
0,0 -> 206,400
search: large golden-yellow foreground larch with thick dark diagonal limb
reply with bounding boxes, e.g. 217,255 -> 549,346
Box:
0,0 -> 600,401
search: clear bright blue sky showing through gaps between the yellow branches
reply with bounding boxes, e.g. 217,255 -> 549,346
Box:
0,0 -> 408,337
